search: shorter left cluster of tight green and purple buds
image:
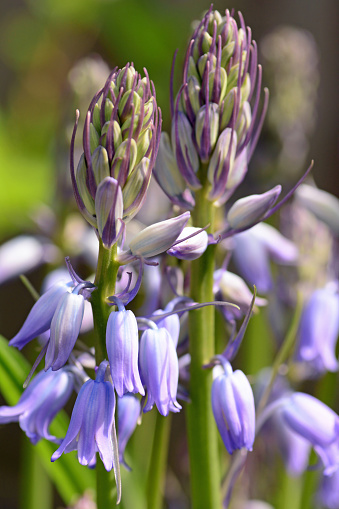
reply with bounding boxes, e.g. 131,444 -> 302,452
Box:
71,64 -> 161,248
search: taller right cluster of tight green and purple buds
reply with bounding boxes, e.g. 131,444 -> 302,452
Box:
155,8 -> 268,208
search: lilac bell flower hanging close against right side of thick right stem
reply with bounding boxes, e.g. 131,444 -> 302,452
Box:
212,361 -> 255,454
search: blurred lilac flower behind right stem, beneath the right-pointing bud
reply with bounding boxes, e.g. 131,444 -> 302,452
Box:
232,223 -> 298,294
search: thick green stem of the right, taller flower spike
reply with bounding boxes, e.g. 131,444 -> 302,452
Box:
187,189 -> 221,509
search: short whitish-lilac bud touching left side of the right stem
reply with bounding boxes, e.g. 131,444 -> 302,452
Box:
167,226 -> 208,260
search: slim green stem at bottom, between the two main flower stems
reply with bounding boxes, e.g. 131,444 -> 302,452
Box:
147,413 -> 171,509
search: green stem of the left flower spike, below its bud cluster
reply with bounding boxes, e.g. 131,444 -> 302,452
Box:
91,240 -> 119,509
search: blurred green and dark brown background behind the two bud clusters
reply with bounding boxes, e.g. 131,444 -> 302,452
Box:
0,0 -> 339,509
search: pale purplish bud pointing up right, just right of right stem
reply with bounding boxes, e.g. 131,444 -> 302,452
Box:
227,186 -> 281,230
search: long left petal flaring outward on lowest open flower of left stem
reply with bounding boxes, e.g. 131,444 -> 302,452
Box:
51,380 -> 94,461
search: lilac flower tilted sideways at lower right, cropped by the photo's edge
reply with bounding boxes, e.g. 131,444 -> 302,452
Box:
278,392 -> 339,475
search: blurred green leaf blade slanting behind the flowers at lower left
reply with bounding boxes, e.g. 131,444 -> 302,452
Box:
0,336 -> 95,504
